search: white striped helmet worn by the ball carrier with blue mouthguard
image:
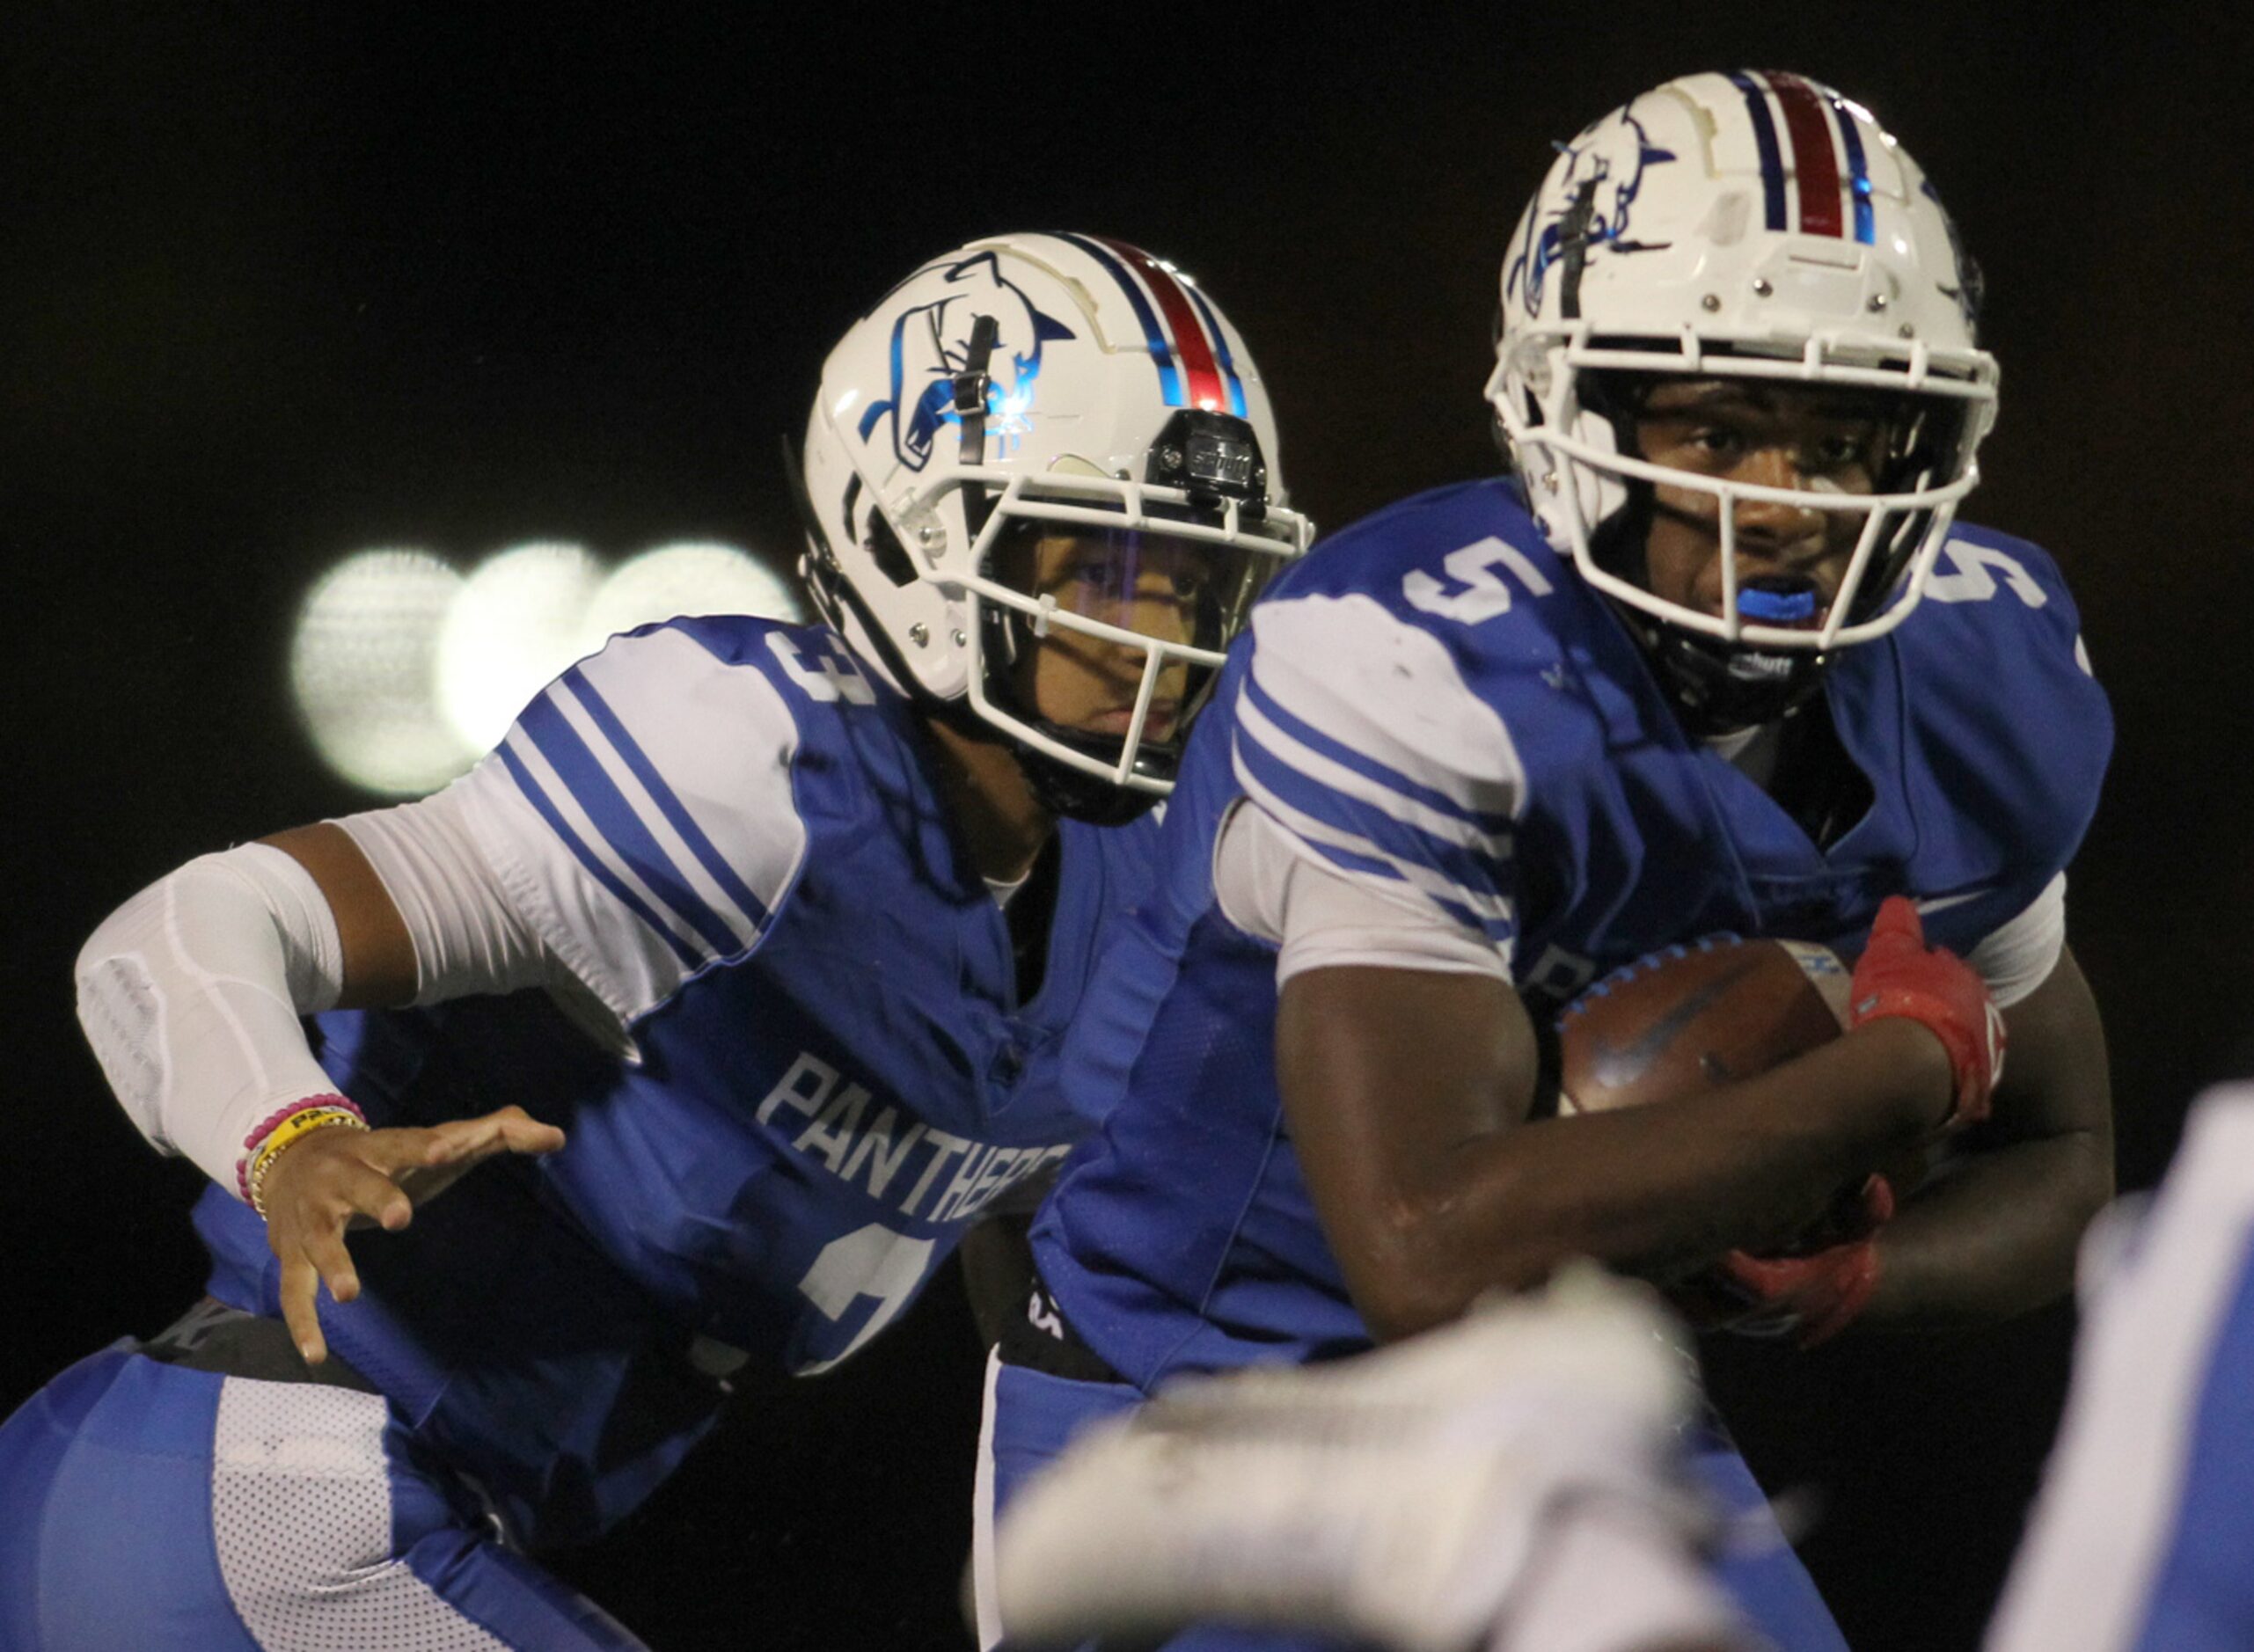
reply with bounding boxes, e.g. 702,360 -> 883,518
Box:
1488,69 -> 1997,730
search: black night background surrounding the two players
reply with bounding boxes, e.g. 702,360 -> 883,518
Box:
0,0 -> 2254,1649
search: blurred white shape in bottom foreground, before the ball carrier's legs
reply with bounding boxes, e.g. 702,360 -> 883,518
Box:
996,1267 -> 1753,1652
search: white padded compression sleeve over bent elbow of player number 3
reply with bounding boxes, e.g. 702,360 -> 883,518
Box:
77,843 -> 345,1192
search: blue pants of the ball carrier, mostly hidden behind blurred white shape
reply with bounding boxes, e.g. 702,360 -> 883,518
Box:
978,1366 -> 1846,1652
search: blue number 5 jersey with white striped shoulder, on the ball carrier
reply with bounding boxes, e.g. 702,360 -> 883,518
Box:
1035,480 -> 2112,1388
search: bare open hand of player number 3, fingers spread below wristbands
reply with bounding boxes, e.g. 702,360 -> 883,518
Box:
264,1107 -> 564,1366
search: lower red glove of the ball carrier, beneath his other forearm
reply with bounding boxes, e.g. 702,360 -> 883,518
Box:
1668,1176 -> 1893,1348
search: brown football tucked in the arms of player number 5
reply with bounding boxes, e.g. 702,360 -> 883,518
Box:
1557,935 -> 1848,1114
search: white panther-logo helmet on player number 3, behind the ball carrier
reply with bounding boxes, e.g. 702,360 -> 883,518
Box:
802,234 -> 1312,818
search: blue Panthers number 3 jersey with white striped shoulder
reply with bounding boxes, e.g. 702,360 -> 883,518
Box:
196,618 -> 1156,1541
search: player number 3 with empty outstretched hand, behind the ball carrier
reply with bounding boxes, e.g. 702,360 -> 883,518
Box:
0,234 -> 1307,1649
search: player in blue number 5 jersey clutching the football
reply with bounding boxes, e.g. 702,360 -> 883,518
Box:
980,72 -> 2112,1648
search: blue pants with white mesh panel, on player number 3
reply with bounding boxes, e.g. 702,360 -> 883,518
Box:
0,1346 -> 642,1652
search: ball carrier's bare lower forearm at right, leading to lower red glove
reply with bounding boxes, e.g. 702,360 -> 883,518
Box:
1864,1134 -> 2112,1330
